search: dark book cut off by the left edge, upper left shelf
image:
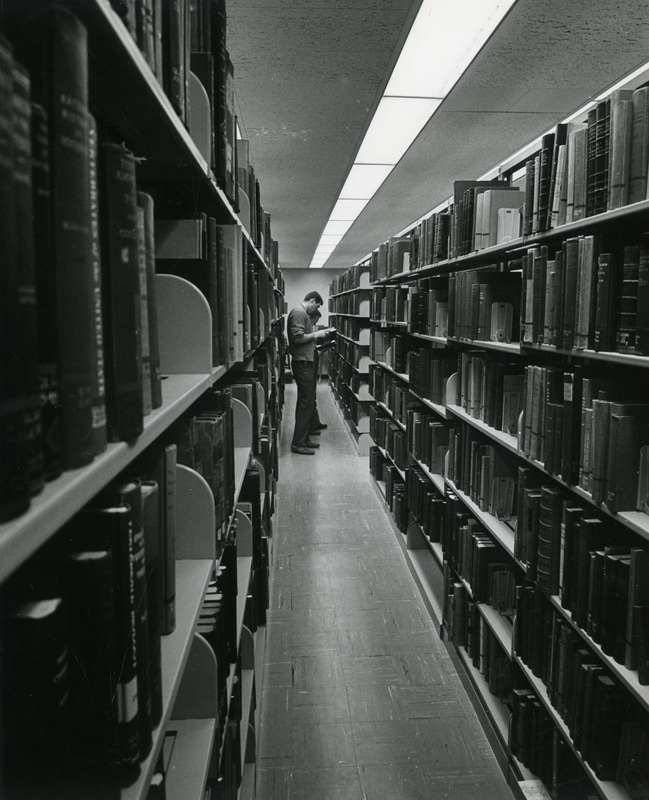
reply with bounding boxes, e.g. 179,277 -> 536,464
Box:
0,39 -> 31,519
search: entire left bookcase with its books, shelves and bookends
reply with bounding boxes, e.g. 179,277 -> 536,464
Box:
0,0 -> 284,800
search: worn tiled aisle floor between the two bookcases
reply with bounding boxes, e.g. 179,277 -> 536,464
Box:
257,383 -> 512,800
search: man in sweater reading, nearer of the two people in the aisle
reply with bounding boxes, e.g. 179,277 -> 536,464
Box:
286,292 -> 333,456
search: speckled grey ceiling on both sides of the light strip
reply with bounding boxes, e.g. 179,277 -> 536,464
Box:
227,0 -> 649,269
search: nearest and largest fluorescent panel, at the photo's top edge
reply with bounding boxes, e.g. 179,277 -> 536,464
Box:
384,0 -> 515,97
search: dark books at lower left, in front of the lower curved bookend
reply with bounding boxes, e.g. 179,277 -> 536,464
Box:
0,466 -> 175,798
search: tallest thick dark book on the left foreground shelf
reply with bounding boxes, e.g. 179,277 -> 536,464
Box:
25,6 -> 96,469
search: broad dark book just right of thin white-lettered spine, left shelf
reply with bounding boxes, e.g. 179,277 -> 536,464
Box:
100,142 -> 143,442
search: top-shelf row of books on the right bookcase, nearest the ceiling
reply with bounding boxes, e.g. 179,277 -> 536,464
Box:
362,86 -> 649,282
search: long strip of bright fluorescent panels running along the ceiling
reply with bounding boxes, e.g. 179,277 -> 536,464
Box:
310,0 -> 516,267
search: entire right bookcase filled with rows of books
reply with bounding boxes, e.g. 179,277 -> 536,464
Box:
331,70 -> 649,800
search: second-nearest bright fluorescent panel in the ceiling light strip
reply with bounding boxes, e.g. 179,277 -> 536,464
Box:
355,97 -> 442,164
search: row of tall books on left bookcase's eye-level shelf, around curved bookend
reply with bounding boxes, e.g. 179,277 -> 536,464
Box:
0,7 -> 276,519
